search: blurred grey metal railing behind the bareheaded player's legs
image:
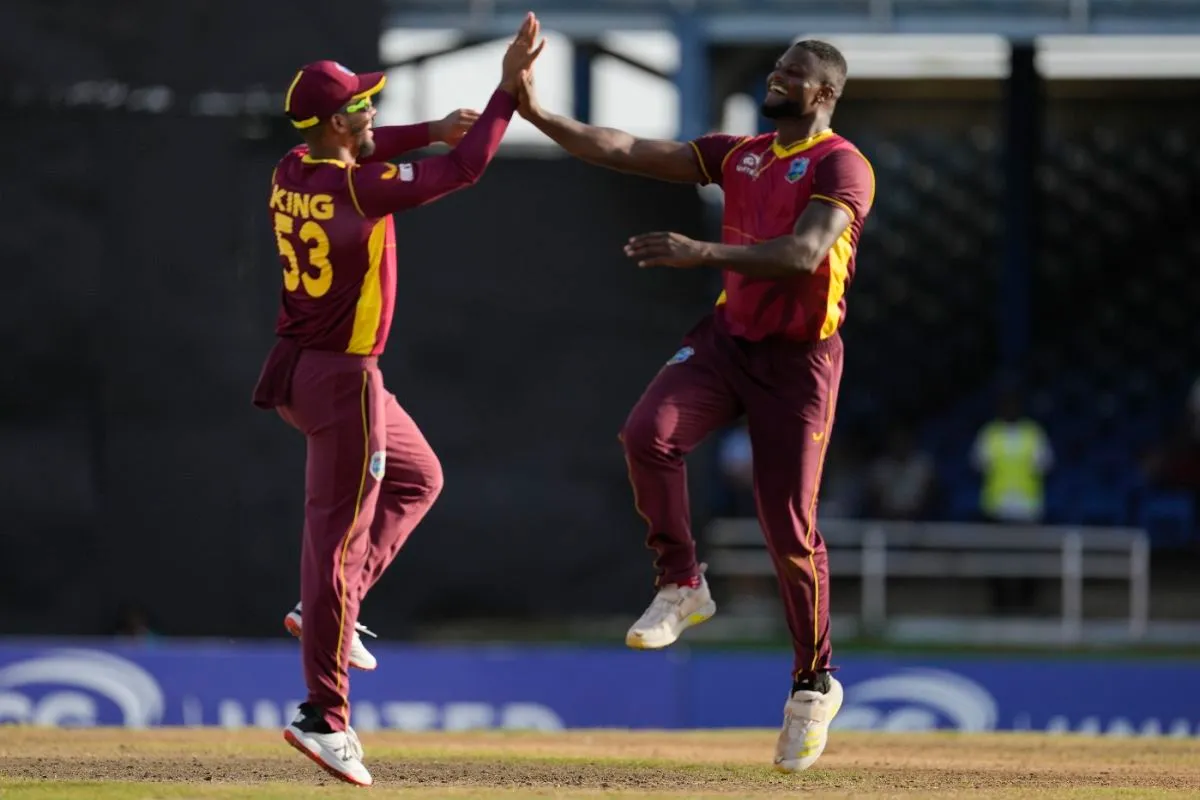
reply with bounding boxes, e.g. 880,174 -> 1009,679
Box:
704,518 -> 1150,643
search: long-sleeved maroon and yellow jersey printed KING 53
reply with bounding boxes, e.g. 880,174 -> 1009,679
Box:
270,90 -> 516,355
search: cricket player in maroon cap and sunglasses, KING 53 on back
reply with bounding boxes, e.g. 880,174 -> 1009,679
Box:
253,13 -> 544,786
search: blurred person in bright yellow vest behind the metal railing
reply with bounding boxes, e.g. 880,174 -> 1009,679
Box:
971,389 -> 1054,612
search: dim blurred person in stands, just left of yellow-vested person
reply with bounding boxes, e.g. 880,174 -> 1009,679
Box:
866,428 -> 937,521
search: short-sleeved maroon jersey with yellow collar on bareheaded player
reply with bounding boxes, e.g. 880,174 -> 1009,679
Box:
690,131 -> 875,342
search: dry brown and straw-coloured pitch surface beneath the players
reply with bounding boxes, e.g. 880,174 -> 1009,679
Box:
0,727 -> 1200,800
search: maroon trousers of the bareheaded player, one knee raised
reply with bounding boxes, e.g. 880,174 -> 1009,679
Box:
622,314 -> 842,678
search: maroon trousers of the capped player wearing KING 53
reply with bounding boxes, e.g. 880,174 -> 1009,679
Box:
260,344 -> 442,730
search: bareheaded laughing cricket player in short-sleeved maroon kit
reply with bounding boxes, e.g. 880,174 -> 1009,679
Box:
520,41 -> 875,772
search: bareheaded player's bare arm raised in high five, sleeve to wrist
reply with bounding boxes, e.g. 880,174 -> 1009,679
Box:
528,112 -> 704,184
